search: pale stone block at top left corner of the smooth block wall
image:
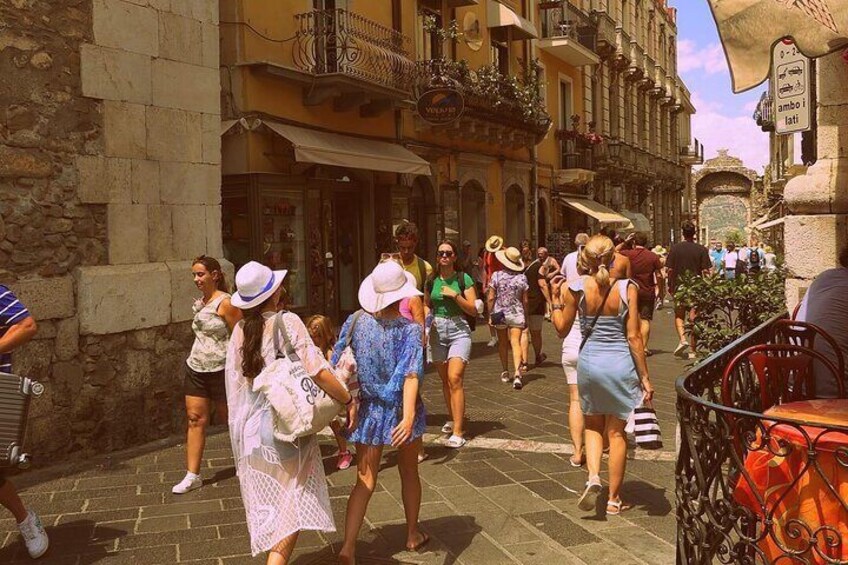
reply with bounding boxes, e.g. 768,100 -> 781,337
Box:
92,0 -> 159,57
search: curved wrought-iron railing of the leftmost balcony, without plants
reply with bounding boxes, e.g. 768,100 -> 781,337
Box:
293,9 -> 414,92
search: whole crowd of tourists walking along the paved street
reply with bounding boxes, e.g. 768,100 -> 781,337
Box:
0,217 -> 816,563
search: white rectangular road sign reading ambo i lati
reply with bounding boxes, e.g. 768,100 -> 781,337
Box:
771,39 -> 813,133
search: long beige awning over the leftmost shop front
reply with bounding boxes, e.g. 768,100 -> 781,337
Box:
262,120 -> 432,176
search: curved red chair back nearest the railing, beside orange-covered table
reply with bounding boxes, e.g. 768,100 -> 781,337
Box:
721,344 -> 845,413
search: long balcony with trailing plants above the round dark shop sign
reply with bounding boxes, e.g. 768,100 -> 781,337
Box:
415,59 -> 551,146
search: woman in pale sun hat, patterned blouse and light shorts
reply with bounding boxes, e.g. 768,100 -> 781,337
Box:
486,247 -> 528,390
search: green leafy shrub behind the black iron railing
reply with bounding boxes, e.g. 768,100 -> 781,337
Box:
674,271 -> 786,358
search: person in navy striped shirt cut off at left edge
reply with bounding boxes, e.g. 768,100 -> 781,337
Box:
0,285 -> 50,559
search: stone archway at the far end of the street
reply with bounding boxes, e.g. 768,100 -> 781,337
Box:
692,149 -> 757,245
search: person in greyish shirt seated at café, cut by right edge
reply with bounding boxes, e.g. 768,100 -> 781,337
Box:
798,245 -> 848,398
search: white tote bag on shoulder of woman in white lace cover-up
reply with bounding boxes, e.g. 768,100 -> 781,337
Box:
253,314 -> 345,442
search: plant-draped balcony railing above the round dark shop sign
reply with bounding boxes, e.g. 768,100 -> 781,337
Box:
415,59 -> 551,140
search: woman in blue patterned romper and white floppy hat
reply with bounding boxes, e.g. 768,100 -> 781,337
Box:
333,261 -> 429,564
